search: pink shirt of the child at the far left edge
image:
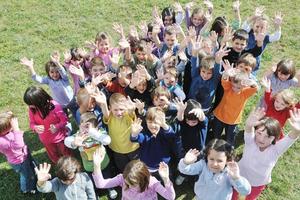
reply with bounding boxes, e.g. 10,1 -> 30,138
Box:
0,131 -> 28,165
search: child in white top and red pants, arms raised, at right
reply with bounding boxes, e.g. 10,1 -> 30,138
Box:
232,109 -> 300,200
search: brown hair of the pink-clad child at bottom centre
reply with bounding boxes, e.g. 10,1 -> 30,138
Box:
123,160 -> 150,192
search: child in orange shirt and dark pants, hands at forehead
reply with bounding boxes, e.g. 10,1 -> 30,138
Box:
212,70 -> 258,146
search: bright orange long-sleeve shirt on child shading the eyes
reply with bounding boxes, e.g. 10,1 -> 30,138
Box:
214,79 -> 257,125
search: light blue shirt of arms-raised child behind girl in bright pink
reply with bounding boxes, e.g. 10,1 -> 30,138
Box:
32,67 -> 74,108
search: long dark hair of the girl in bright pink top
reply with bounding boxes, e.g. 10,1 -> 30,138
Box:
23,86 -> 55,119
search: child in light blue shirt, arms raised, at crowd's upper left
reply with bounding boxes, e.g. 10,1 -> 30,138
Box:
21,52 -> 78,122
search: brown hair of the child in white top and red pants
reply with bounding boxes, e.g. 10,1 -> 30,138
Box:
254,117 -> 281,144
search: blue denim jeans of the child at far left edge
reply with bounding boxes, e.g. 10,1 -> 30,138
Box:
10,155 -> 37,192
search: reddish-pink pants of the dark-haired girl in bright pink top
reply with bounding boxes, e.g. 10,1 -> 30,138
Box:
44,141 -> 72,164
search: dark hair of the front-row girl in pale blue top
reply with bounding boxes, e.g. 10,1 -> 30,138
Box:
204,139 -> 234,162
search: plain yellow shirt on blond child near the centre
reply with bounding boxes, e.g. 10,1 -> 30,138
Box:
103,113 -> 139,154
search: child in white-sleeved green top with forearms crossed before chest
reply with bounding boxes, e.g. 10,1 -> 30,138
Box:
64,112 -> 117,199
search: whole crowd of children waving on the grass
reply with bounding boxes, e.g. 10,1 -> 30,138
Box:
0,0 -> 300,200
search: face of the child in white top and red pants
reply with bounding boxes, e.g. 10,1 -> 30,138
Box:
255,126 -> 275,150
